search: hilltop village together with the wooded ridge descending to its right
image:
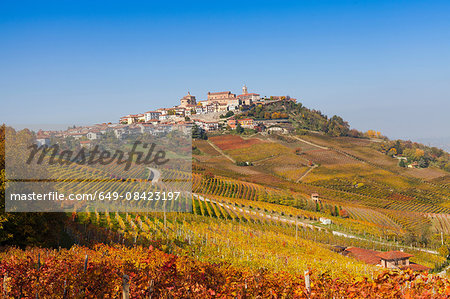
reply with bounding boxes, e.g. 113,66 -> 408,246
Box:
36,85 -> 450,171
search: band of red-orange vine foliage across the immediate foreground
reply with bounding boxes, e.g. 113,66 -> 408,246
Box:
0,245 -> 450,298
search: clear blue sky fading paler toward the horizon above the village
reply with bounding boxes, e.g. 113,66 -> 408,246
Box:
0,0 -> 450,147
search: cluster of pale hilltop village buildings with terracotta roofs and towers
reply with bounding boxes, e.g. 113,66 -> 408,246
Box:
37,85 -> 297,146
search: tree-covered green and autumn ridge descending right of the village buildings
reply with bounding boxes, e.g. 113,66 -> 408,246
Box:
235,99 -> 450,172
